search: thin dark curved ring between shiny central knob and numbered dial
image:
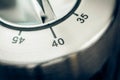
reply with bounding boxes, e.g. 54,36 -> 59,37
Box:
0,0 -> 81,31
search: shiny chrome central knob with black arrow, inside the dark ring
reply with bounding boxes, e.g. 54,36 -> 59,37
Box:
0,0 -> 77,25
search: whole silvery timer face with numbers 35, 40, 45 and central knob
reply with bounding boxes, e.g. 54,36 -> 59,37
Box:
0,0 -> 116,64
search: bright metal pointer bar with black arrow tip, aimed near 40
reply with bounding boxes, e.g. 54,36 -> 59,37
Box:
33,0 -> 56,23
